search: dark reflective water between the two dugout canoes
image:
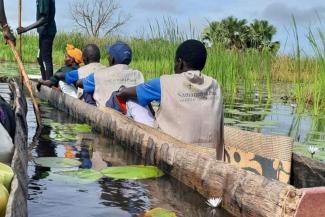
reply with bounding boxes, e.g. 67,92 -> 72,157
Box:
28,104 -> 230,217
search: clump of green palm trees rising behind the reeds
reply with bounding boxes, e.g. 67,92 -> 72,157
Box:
203,16 -> 280,52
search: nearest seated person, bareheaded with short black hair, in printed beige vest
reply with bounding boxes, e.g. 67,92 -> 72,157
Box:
118,40 -> 224,160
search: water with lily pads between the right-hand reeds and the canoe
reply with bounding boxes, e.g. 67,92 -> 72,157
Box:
225,84 -> 325,161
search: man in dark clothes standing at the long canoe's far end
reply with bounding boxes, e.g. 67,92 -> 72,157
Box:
17,0 -> 56,80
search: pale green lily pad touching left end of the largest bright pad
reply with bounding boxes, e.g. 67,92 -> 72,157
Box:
56,169 -> 103,184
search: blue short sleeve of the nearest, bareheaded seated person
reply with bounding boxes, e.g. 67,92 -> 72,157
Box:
136,78 -> 161,107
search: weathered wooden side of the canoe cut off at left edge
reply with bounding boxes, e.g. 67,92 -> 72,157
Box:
1,78 -> 28,217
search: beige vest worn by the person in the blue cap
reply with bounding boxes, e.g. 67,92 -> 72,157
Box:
94,64 -> 144,107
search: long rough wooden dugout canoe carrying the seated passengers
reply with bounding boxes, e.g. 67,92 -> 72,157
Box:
33,82 -> 325,217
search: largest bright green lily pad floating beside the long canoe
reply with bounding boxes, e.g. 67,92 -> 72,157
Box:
100,165 -> 164,180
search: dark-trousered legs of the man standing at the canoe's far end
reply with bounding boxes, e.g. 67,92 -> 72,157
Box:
40,35 -> 55,80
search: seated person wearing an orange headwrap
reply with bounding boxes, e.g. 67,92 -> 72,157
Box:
37,44 -> 83,90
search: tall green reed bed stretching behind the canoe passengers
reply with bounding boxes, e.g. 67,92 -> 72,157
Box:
0,31 -> 325,115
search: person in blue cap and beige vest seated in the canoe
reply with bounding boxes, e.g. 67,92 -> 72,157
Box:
77,41 -> 154,126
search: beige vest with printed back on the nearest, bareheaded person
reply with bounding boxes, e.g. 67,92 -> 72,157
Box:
156,71 -> 224,159
